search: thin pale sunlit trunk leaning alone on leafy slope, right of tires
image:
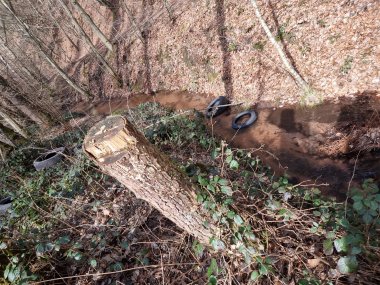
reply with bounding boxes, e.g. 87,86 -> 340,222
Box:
250,0 -> 310,90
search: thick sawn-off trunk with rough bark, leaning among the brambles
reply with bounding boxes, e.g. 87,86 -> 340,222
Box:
83,116 -> 218,244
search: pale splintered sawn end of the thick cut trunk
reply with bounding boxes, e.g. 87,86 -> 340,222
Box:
83,116 -> 137,163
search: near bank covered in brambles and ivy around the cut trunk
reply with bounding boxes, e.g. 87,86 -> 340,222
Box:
0,103 -> 380,285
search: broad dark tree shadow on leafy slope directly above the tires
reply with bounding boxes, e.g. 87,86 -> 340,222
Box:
215,0 -> 233,98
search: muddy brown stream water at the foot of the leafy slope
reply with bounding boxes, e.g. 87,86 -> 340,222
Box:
74,91 -> 380,199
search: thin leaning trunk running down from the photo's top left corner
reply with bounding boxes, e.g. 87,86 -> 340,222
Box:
0,0 -> 91,99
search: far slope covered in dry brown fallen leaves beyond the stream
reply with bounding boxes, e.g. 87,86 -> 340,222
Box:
57,0 -> 380,106
